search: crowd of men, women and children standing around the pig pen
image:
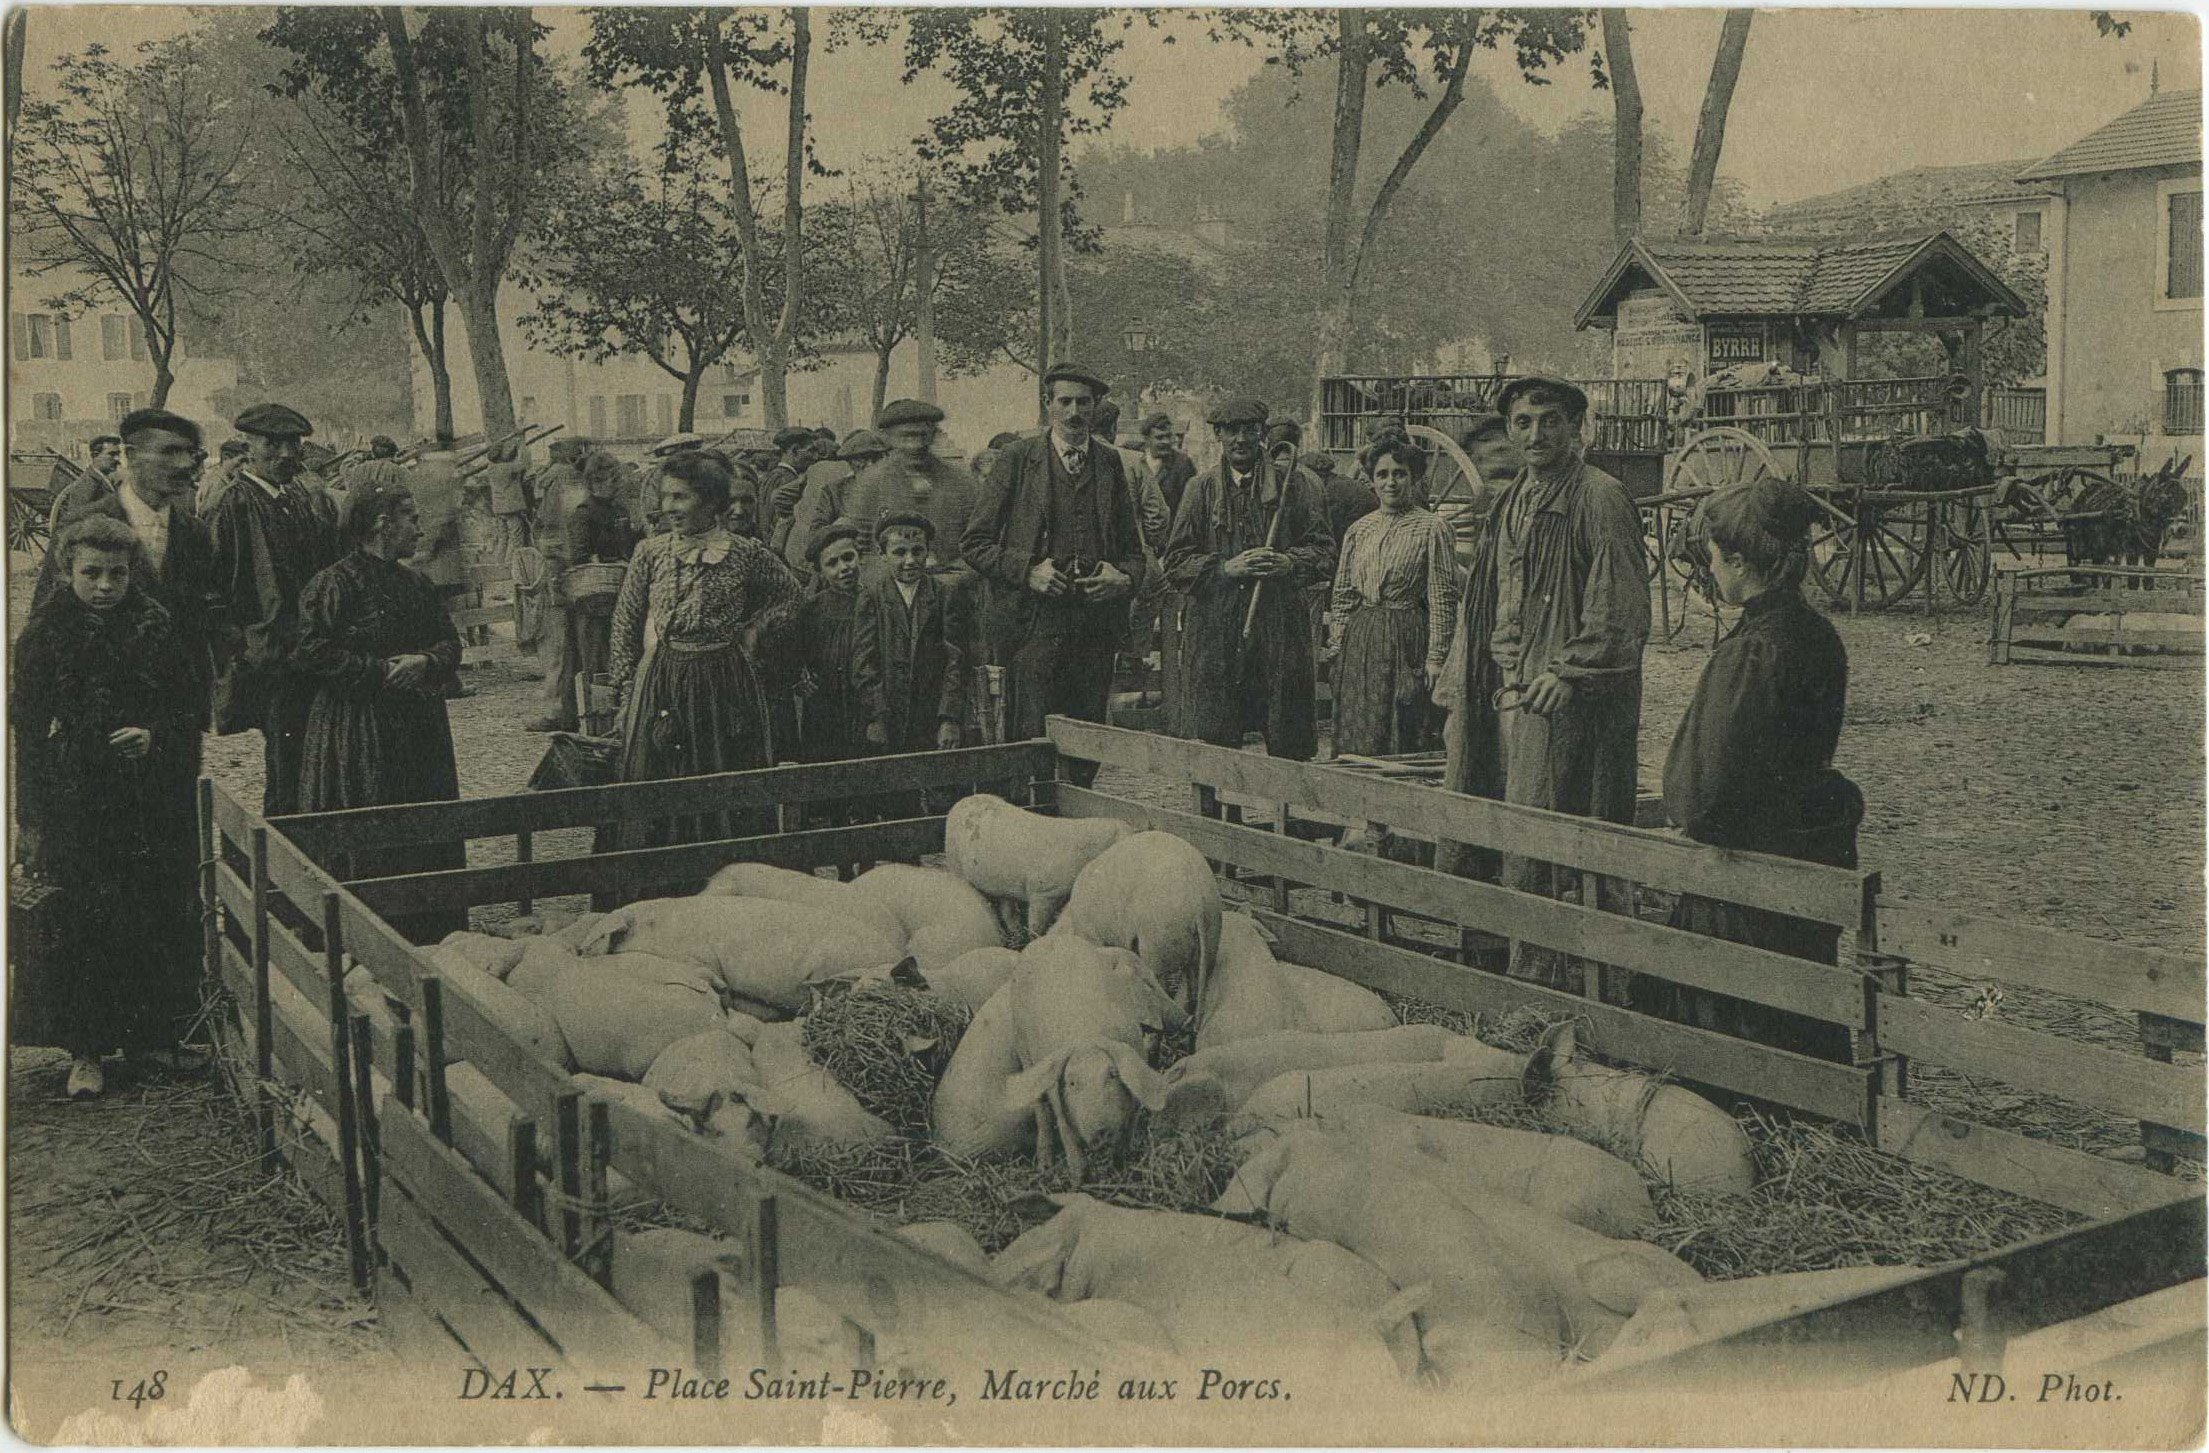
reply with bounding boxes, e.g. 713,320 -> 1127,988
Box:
9,364 -> 1862,1095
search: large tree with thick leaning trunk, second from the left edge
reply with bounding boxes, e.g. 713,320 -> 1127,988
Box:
263,7 -> 601,433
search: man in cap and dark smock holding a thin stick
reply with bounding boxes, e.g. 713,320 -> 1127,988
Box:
1166,397 -> 1334,762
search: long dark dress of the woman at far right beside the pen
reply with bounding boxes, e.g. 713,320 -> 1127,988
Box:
1635,587 -> 1864,1060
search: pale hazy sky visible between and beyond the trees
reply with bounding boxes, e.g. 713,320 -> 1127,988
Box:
27,7 -> 2202,205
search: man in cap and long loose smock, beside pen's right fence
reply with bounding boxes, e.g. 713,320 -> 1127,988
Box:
1449,375 -> 1650,1003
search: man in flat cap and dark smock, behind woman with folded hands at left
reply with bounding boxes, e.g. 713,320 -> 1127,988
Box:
208,404 -> 345,817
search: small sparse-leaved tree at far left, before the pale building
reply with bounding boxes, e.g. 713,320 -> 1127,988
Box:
13,35 -> 252,406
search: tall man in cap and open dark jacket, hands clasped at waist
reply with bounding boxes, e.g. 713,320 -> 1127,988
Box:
961,364 -> 1142,768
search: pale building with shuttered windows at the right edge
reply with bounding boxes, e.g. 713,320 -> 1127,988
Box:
2019,91 -> 2202,473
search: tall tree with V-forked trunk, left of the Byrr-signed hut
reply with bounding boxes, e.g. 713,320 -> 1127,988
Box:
1215,7 -> 1586,417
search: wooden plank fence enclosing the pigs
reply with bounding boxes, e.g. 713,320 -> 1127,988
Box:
201,718 -> 2205,1427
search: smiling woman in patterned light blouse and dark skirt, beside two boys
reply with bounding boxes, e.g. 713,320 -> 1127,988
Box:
599,453 -> 797,850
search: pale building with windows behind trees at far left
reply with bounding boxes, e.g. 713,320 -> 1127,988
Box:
7,267 -> 239,459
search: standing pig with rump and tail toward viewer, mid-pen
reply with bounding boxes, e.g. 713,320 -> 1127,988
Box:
1054,832 -> 1219,1011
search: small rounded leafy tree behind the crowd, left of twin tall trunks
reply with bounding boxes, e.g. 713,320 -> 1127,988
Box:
521,139 -> 744,431
